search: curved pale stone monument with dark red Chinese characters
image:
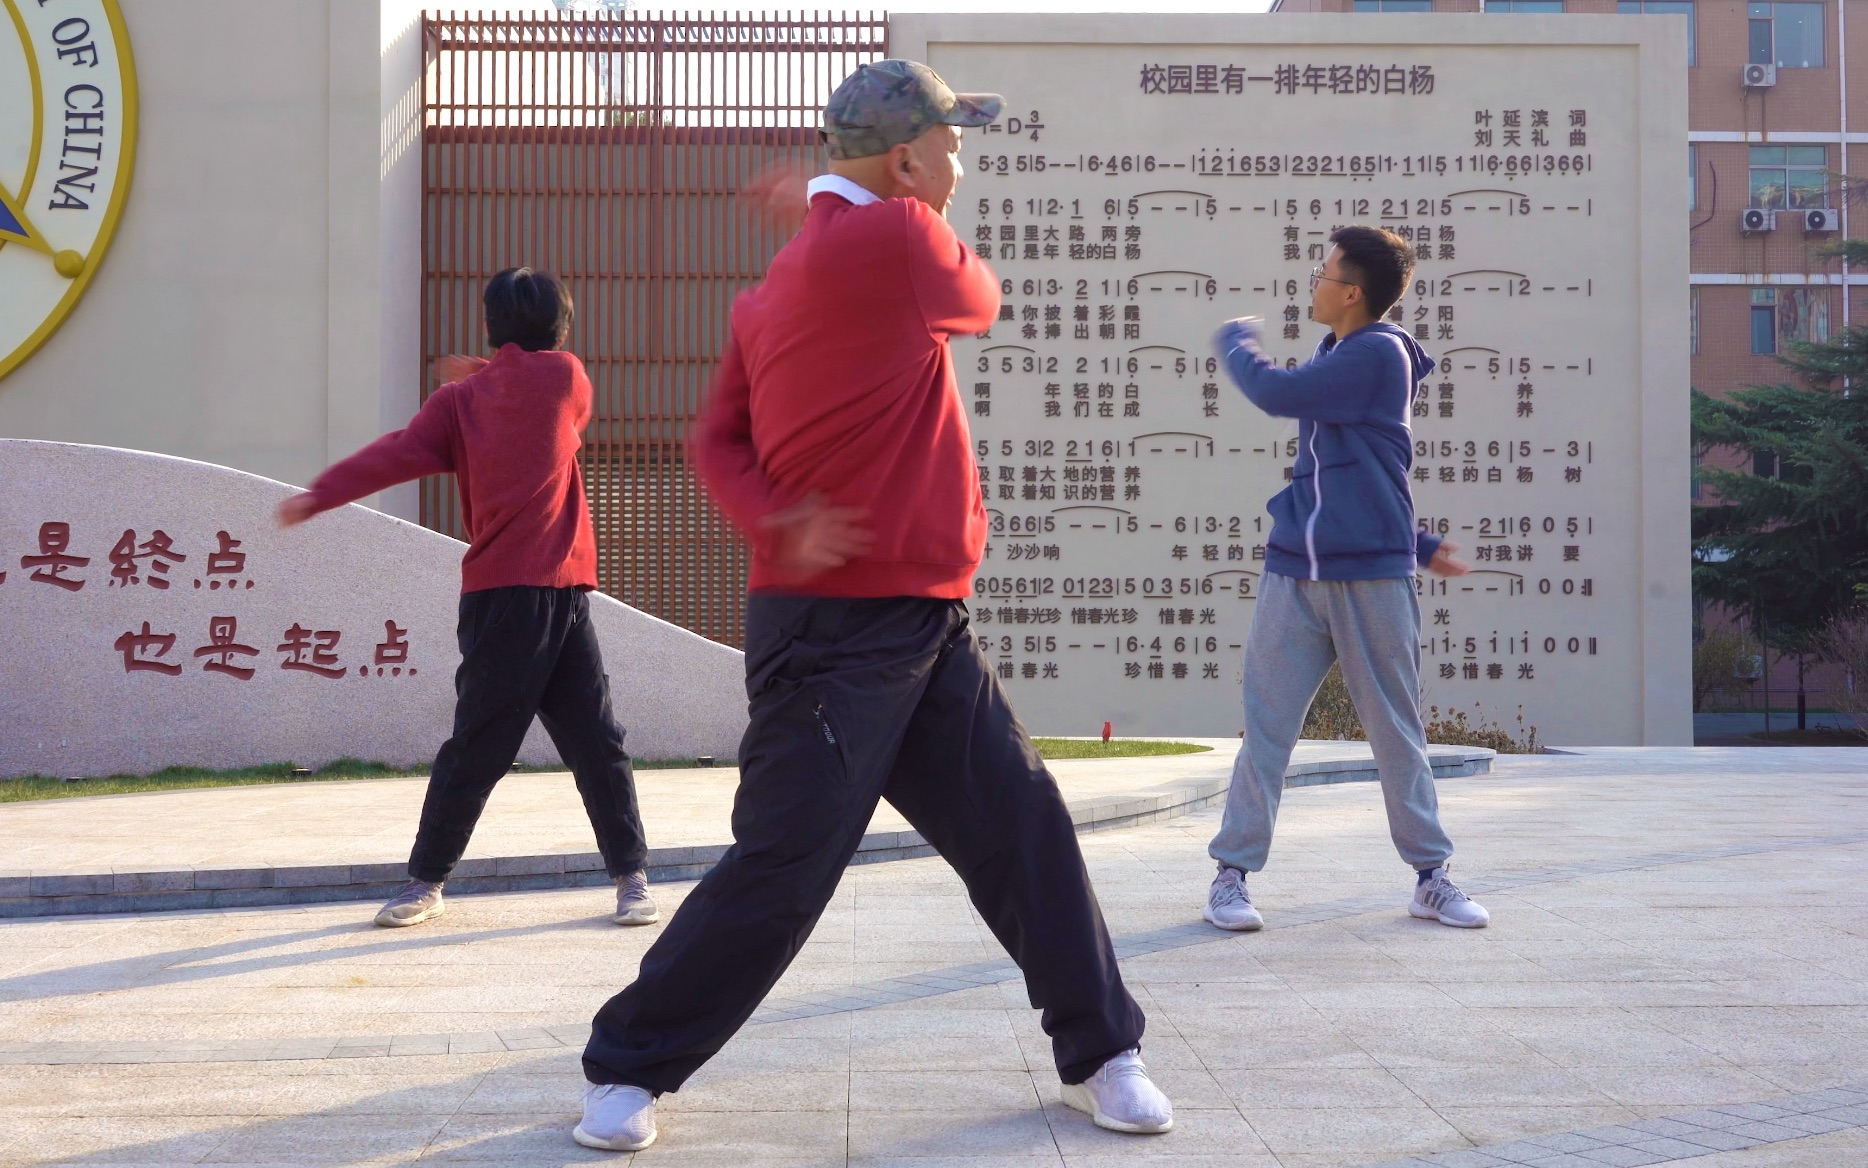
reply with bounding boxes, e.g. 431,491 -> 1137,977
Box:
0,439 -> 745,777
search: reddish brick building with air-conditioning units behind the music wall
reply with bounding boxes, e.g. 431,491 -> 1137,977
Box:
1272,0 -> 1868,721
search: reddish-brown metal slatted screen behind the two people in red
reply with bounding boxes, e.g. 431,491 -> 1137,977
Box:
422,13 -> 887,645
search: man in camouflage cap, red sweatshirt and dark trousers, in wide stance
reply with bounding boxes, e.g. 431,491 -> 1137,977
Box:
573,60 -> 1173,1151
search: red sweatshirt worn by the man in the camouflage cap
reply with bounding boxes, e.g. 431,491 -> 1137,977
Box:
691,192 -> 999,600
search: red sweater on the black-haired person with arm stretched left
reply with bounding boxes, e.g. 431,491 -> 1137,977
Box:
312,344 -> 596,592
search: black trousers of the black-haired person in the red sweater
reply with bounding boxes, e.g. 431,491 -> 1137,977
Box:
409,587 -> 648,882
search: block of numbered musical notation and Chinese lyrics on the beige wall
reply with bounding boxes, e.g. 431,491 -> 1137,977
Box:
951,45 -> 1638,733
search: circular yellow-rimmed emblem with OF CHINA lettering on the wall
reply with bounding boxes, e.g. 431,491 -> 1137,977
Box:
0,0 -> 136,377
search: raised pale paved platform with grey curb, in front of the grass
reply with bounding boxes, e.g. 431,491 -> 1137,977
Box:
0,738 -> 1493,918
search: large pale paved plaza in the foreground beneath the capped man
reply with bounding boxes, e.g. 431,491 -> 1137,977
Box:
0,749 -> 1868,1168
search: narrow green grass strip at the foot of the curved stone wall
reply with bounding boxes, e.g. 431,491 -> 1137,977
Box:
0,738 -> 1212,804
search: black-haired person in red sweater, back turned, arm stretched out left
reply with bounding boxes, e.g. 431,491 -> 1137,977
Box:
278,267 -> 659,927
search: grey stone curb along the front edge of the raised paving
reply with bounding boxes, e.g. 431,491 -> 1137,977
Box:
0,746 -> 1494,918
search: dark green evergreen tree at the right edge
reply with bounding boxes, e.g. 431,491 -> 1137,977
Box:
1692,239 -> 1868,654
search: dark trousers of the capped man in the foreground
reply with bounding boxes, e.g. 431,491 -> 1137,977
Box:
585,596 -> 1143,1093
